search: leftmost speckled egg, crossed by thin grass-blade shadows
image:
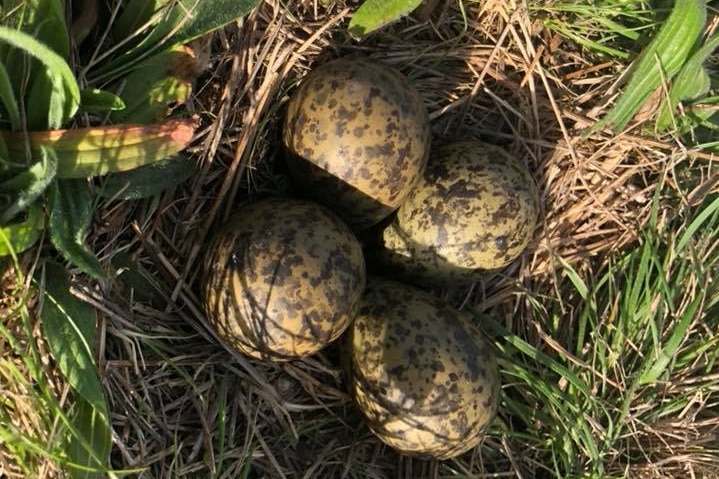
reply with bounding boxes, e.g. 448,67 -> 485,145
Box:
202,198 -> 366,361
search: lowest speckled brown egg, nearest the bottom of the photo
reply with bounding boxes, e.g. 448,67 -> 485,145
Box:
348,277 -> 500,459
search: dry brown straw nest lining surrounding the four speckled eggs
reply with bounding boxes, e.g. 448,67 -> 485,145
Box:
81,1 -> 696,478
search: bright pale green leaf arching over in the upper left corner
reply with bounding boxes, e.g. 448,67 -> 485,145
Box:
0,26 -> 80,127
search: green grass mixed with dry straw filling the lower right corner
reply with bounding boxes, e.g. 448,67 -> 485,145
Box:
481,177 -> 719,478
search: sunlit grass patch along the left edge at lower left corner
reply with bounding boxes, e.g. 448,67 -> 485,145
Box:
0,256 -> 69,479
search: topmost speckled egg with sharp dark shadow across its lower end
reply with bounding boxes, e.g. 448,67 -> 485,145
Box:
283,57 -> 431,230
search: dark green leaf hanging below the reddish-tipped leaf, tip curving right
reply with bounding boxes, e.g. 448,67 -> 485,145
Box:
50,179 -> 104,278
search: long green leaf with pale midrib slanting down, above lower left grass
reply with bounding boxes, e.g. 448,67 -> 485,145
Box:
38,261 -> 105,411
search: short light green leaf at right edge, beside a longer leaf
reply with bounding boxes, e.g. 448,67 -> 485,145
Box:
657,34 -> 719,130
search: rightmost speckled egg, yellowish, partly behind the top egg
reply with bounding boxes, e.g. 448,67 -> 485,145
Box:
379,141 -> 539,283
